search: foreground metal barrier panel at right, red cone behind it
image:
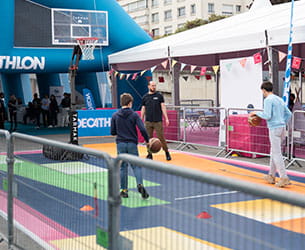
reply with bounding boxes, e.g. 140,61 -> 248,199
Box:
113,154 -> 305,250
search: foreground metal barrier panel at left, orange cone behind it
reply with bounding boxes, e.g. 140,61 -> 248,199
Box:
0,133 -> 113,249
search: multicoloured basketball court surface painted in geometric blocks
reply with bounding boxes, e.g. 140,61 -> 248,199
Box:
0,143 -> 305,250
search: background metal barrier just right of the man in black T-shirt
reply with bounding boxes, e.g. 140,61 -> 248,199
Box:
164,106 -> 226,153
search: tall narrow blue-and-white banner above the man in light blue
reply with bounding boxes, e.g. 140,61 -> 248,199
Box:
283,0 -> 294,105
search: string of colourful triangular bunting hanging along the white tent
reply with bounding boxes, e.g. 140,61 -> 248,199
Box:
109,48 -> 305,82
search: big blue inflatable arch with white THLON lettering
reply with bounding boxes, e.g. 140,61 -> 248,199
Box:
0,0 -> 151,109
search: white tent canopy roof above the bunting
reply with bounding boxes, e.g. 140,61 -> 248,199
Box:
109,0 -> 305,69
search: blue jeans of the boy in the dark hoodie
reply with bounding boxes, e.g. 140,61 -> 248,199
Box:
117,142 -> 143,189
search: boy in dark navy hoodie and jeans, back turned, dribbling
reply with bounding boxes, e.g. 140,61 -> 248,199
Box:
111,93 -> 149,199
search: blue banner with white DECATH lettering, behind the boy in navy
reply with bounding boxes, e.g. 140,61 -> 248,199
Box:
78,109 -> 117,137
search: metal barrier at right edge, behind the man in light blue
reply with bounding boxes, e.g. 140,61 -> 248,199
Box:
286,110 -> 305,168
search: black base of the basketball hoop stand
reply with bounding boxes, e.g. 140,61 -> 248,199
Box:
42,145 -> 84,161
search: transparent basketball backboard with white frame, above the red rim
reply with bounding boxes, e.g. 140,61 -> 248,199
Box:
51,9 -> 108,46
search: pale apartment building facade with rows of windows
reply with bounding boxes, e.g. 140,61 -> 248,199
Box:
118,0 -> 252,37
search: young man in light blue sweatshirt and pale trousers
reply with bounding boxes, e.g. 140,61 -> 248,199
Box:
250,82 -> 291,187
